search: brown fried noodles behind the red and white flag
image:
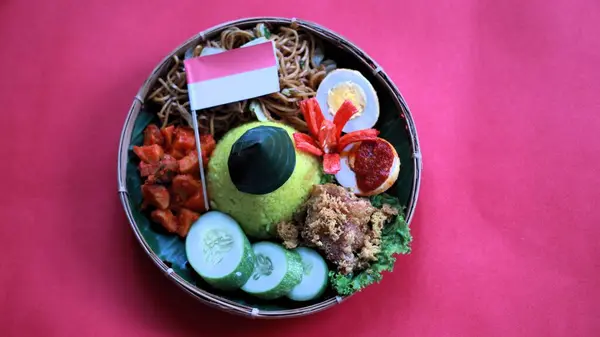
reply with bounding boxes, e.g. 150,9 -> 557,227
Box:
149,24 -> 326,137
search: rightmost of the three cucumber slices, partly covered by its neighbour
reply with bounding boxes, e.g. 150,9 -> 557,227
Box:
287,247 -> 329,301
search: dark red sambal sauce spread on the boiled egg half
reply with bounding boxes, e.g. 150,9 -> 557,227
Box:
352,140 -> 394,192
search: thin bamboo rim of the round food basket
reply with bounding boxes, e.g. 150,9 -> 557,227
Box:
117,17 -> 423,319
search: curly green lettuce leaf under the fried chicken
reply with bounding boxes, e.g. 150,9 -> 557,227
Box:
329,194 -> 412,296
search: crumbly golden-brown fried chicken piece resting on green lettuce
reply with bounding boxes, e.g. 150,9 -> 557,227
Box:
277,184 -> 397,274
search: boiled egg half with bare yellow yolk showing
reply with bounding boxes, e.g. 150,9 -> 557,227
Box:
317,69 -> 379,133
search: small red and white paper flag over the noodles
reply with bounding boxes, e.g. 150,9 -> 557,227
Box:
184,41 -> 280,110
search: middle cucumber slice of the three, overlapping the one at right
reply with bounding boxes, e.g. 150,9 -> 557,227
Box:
242,241 -> 303,299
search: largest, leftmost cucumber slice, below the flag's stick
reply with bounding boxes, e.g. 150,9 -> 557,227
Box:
185,211 -> 254,290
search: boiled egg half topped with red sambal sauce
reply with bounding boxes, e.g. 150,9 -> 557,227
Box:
335,138 -> 400,196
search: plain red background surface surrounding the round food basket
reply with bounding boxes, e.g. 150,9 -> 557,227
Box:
0,0 -> 600,337
